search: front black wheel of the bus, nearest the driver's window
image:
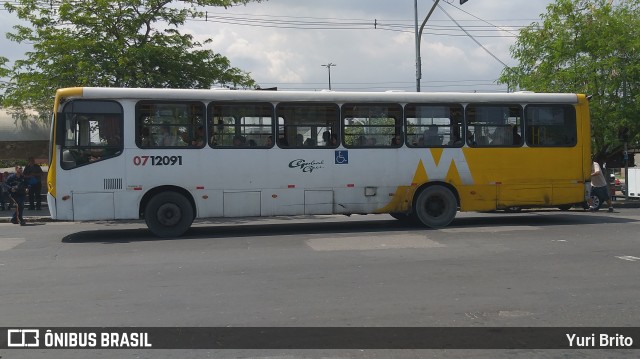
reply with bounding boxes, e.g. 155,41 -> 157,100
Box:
144,192 -> 194,238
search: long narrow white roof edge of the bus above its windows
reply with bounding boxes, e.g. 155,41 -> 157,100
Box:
57,87 -> 579,104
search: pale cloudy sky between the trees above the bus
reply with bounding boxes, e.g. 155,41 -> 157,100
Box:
0,0 -> 553,92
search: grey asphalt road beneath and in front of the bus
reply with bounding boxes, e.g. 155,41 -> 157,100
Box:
0,208 -> 640,358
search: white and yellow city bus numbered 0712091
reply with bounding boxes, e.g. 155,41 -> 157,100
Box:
47,87 -> 591,237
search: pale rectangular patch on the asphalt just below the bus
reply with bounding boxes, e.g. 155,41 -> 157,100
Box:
306,234 -> 445,251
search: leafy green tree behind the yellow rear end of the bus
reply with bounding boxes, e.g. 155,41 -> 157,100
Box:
499,0 -> 640,160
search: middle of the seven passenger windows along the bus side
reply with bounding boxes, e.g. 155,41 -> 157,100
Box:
342,103 -> 403,148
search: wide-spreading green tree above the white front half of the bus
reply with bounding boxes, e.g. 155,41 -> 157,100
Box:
0,0 -> 261,119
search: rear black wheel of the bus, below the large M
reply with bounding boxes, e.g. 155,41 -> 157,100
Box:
414,185 -> 458,228
